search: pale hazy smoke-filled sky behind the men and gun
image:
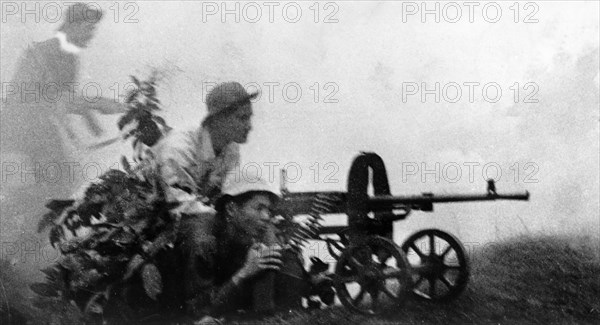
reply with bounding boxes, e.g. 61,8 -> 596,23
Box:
1,1 -> 600,278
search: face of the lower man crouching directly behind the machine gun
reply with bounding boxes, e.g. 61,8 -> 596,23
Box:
233,194 -> 273,239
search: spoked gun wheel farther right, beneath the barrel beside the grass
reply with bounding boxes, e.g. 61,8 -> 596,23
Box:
402,229 -> 469,301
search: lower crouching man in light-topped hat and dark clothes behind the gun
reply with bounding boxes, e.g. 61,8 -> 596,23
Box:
173,174 -> 290,317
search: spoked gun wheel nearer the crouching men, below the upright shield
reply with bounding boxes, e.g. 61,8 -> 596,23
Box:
334,236 -> 412,315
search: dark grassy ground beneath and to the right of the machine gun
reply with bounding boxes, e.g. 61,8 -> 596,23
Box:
0,237 -> 600,325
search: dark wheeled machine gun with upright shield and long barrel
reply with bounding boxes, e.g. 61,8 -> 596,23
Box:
278,153 -> 529,315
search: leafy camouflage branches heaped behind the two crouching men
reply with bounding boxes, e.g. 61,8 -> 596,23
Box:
31,73 -> 179,316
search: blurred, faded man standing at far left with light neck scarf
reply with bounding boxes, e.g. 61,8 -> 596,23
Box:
0,3 -> 125,251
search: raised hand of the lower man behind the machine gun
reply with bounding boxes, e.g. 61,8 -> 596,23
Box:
236,243 -> 283,280
